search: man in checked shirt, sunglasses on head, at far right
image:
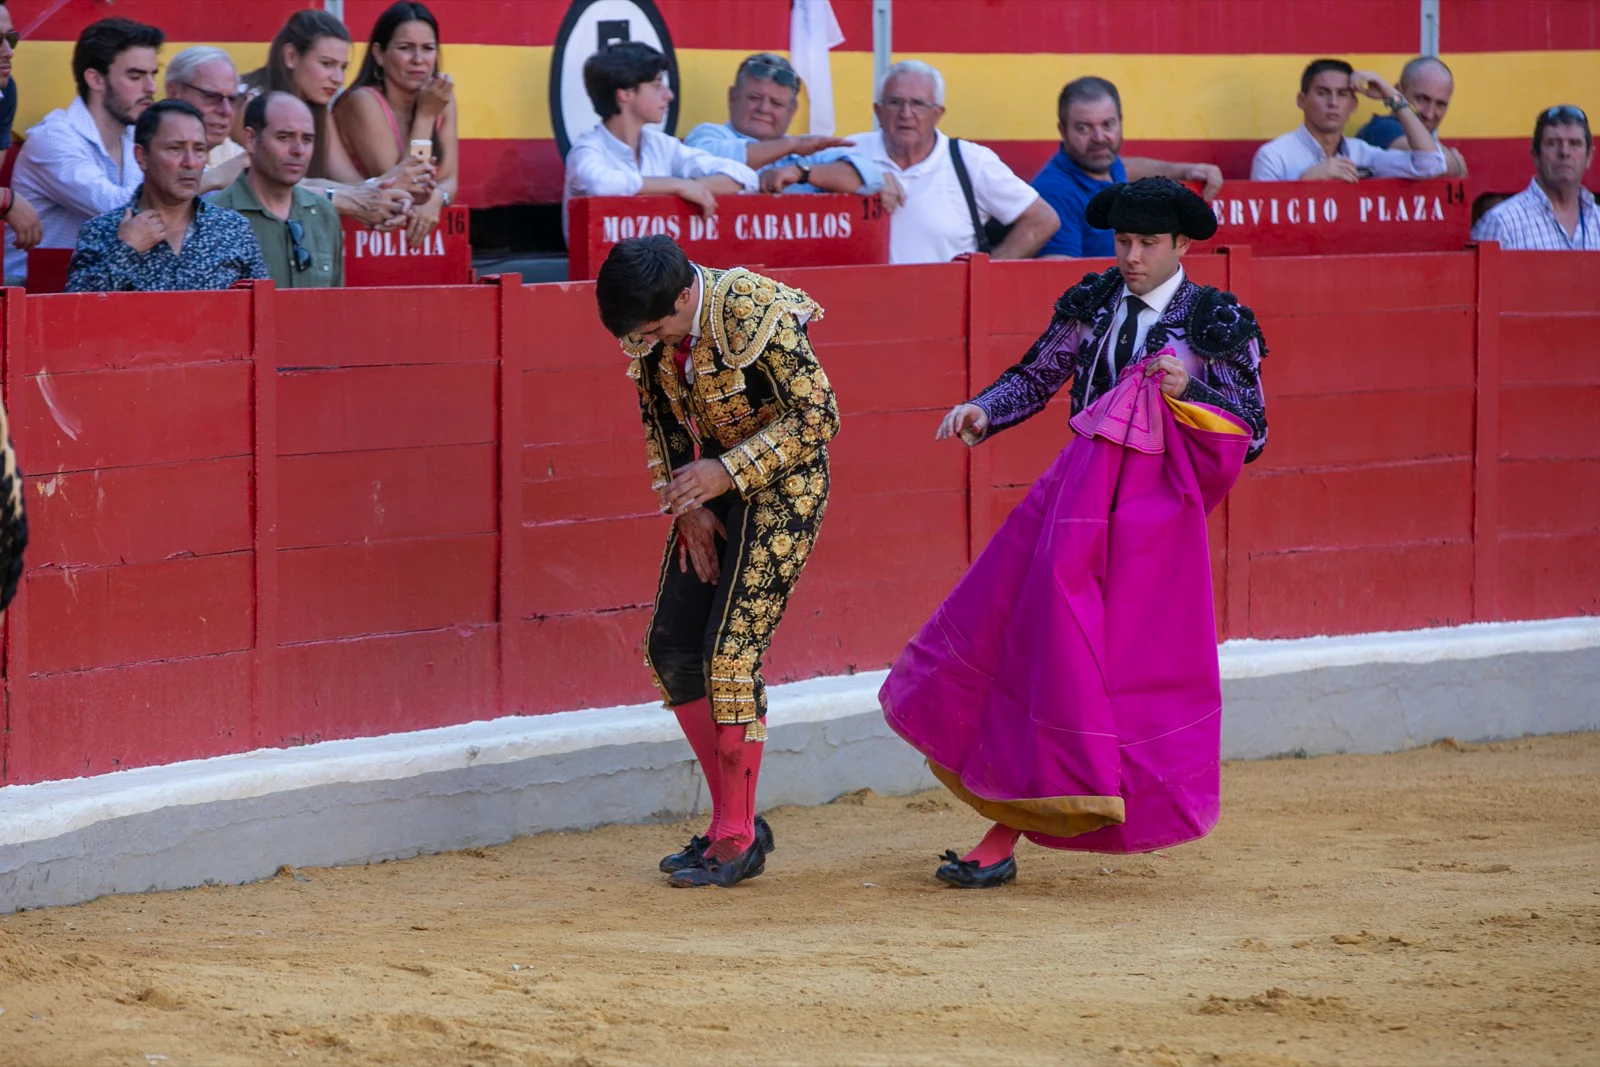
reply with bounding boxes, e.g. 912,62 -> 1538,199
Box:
1472,104 -> 1600,251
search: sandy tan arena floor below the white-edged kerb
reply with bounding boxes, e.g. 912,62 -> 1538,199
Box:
0,734 -> 1600,1067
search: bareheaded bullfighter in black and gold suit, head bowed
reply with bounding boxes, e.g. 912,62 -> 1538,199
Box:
595,237 -> 838,888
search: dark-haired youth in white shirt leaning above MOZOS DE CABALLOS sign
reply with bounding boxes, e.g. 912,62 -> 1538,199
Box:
562,42 -> 758,229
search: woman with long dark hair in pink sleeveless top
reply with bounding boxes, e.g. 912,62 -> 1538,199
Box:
334,0 -> 461,246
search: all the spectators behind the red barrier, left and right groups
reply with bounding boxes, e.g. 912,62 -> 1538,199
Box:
0,10 -> 1600,290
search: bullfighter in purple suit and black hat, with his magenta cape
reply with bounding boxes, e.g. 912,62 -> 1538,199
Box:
880,178 -> 1267,888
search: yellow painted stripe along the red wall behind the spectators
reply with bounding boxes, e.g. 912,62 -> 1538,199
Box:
14,42 -> 1600,141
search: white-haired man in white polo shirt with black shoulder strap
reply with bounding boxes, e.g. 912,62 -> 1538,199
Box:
850,59 -> 1061,262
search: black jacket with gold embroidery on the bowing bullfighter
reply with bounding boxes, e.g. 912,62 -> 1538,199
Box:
622,267 -> 838,510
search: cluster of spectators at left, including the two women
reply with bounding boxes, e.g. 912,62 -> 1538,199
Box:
0,0 -> 459,291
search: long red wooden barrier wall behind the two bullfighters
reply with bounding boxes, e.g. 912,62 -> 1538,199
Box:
0,248 -> 1600,784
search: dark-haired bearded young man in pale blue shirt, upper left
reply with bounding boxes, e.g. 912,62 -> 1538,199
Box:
5,19 -> 163,282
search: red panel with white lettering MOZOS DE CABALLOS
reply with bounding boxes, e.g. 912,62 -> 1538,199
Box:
566,194 -> 890,280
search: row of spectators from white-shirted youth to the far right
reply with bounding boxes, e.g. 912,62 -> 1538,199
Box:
562,42 -> 1600,262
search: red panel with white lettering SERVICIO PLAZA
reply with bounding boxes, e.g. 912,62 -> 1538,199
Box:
1190,179 -> 1472,256
